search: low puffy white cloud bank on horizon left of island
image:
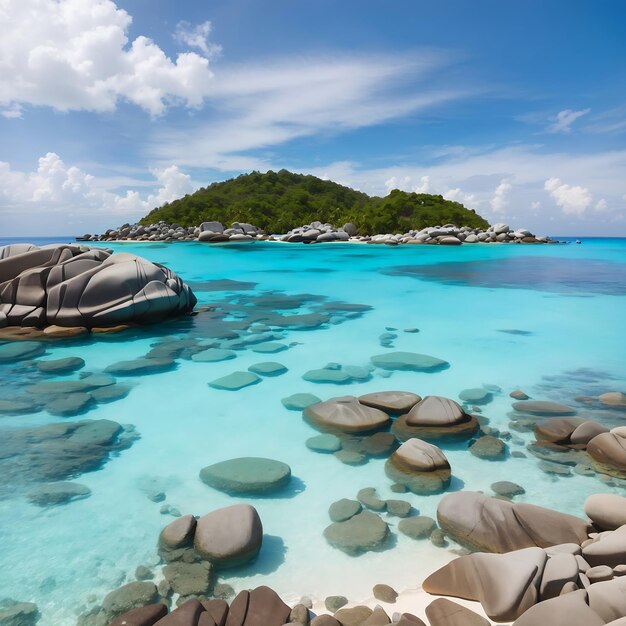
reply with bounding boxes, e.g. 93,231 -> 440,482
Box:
0,152 -> 196,219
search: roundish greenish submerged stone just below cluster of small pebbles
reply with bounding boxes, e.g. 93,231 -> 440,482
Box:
324,511 -> 389,552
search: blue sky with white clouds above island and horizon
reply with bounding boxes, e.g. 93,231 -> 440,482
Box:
0,0 -> 626,236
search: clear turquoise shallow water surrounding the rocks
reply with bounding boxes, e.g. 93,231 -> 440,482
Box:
0,239 -> 626,625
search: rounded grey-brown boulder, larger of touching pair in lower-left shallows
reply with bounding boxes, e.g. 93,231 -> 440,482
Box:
194,504 -> 263,567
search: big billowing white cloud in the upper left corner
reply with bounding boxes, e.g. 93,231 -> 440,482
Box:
0,0 -> 218,117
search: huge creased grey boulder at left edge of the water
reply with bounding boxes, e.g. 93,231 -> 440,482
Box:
0,244 -> 196,329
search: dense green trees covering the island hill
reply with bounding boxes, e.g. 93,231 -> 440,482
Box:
141,170 -> 489,234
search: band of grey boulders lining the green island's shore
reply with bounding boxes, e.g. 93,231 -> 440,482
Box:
77,221 -> 556,246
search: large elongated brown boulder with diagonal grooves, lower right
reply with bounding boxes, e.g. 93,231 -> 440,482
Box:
437,491 -> 588,552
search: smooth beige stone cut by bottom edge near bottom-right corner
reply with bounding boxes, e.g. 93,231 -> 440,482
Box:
514,589 -> 605,626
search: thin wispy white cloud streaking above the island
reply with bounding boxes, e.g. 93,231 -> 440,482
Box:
149,52 -> 470,168
